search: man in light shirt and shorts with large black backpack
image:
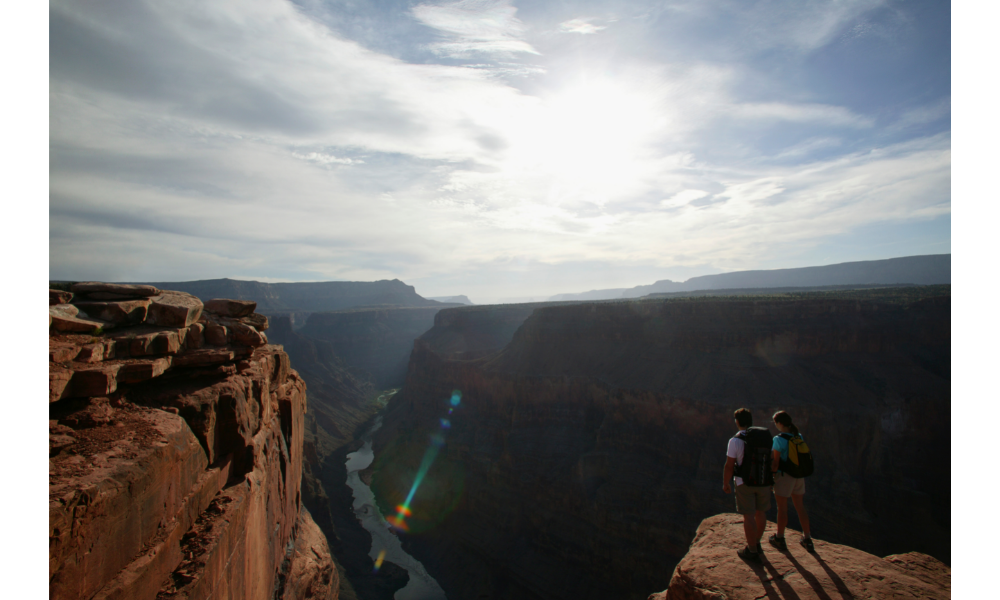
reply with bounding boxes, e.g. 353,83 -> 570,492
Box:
722,408 -> 773,562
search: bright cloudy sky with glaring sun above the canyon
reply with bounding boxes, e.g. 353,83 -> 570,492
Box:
48,0 -> 952,303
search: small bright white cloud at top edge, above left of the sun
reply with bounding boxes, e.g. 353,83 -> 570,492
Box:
411,0 -> 538,58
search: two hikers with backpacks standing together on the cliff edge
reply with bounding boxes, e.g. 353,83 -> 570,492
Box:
722,408 -> 813,562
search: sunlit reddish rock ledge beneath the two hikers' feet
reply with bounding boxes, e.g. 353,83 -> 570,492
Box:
649,514 -> 951,600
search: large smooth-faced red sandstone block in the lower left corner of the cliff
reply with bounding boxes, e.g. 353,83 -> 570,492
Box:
49,405 -> 207,600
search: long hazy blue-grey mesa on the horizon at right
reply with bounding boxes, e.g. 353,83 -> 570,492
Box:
549,254 -> 951,302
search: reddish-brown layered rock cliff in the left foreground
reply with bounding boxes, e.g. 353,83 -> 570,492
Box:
49,283 -> 338,599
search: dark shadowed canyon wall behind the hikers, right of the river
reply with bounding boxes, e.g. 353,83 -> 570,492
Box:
373,290 -> 951,599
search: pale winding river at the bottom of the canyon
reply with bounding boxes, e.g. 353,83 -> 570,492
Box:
345,417 -> 446,600
